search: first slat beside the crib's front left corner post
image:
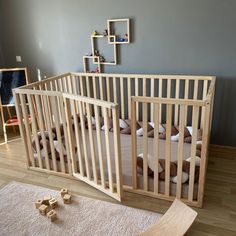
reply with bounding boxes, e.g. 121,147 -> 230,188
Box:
20,94 -> 35,166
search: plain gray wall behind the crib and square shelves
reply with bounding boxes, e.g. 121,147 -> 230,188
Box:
0,0 -> 236,146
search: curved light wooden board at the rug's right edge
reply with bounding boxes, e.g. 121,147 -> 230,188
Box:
141,199 -> 197,236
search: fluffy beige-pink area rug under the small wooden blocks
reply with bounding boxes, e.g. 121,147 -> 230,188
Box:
0,182 -> 162,236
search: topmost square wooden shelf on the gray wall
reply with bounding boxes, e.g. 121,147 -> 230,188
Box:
107,18 -> 130,44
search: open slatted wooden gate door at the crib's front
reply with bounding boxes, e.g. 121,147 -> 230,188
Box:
64,94 -> 123,201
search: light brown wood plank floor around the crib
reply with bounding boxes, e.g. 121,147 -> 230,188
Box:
0,136 -> 236,236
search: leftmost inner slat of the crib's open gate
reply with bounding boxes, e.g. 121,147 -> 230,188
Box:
70,101 -> 84,176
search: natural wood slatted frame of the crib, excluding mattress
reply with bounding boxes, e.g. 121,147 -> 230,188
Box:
14,73 -> 215,207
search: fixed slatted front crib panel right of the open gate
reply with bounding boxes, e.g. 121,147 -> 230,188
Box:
128,96 -> 212,207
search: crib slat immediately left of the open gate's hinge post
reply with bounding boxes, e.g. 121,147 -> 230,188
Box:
50,96 -> 66,173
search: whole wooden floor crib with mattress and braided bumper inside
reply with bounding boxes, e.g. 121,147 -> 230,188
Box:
14,73 -> 215,207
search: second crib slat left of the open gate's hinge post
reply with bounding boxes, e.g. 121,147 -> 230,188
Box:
43,96 -> 57,171
